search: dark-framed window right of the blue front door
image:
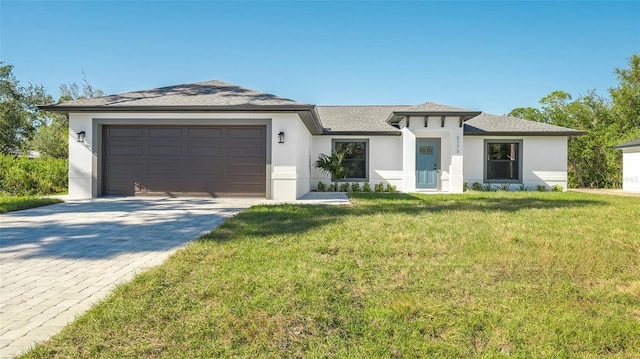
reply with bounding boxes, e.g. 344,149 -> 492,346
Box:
485,140 -> 522,182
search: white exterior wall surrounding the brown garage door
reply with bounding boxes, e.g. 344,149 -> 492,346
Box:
69,112 -> 311,200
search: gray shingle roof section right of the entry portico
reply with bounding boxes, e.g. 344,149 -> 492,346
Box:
464,113 -> 584,136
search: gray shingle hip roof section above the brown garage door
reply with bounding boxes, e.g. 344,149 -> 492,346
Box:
45,80 -> 310,109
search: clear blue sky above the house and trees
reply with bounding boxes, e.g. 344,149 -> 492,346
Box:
0,0 -> 640,114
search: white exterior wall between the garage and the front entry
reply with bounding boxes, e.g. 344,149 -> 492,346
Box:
309,135 -> 403,191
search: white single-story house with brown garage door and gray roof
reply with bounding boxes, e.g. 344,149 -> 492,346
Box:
40,81 -> 582,200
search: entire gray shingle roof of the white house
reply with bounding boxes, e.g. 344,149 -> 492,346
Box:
39,80 -> 584,137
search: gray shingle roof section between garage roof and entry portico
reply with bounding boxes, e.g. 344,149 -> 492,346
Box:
316,106 -> 409,134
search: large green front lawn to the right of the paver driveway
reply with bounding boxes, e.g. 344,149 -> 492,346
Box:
21,192 -> 640,358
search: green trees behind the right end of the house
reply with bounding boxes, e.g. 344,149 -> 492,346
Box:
509,54 -> 640,188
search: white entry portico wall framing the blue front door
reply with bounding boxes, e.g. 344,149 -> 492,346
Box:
401,116 -> 464,193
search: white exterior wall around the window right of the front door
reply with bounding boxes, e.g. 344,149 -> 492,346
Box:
464,136 -> 567,190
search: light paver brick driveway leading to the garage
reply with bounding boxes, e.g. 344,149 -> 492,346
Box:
0,198 -> 265,357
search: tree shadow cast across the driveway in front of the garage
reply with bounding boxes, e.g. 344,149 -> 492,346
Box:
0,198 -> 260,259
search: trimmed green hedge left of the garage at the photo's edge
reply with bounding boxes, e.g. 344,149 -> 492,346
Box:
0,154 -> 69,196
